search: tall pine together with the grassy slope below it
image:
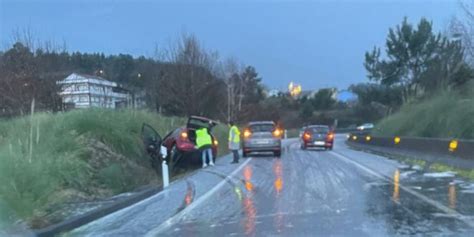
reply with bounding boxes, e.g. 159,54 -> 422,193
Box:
358,5 -> 474,139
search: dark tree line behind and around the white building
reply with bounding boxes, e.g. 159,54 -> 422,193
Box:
0,34 -> 264,120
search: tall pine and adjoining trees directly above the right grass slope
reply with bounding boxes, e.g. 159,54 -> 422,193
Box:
350,13 -> 474,120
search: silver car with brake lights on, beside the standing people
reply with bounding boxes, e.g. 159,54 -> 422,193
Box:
243,121 -> 283,157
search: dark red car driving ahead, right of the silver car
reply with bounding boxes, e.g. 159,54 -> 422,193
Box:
301,125 -> 334,150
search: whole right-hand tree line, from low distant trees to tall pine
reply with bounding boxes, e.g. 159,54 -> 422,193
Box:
273,12 -> 474,129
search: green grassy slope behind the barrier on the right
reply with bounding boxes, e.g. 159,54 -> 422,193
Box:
373,87 -> 474,139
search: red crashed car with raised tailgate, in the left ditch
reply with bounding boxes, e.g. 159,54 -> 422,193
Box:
163,116 -> 218,164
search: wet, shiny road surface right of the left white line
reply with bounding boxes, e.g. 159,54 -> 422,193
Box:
159,136 -> 474,236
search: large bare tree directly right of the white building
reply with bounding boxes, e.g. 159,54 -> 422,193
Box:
159,33 -> 227,116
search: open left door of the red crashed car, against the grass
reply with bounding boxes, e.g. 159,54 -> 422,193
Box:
142,123 -> 163,172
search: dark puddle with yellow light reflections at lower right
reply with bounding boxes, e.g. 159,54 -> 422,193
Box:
366,174 -> 469,236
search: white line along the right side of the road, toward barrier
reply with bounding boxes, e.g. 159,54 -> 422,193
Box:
330,151 -> 474,227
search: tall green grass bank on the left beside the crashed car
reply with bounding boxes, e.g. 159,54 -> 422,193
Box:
0,110 -> 227,228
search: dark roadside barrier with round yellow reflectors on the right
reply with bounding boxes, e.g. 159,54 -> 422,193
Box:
348,132 -> 474,160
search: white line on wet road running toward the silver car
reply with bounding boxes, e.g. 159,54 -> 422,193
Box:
145,158 -> 252,237
